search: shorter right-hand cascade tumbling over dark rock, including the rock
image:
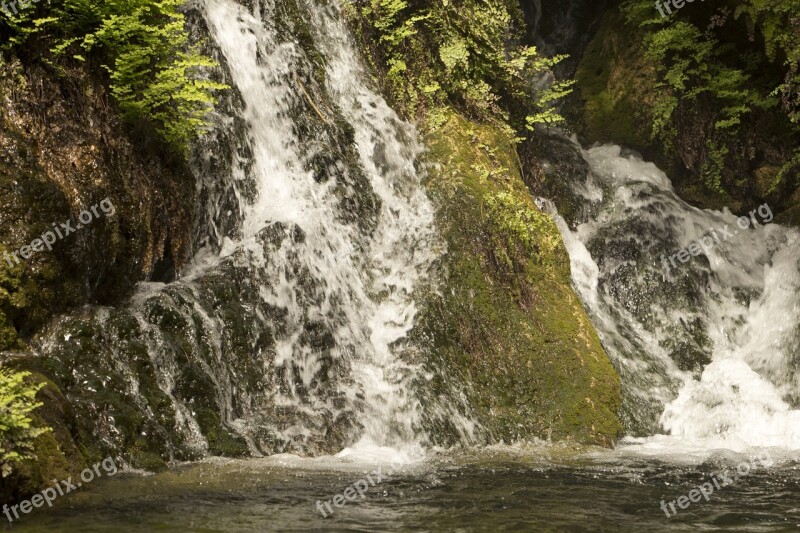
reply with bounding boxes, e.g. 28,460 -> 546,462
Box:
557,140 -> 800,450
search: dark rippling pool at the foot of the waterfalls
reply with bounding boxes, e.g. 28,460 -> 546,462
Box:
9,446 -> 800,532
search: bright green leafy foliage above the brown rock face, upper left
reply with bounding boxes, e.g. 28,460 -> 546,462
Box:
1,0 -> 226,152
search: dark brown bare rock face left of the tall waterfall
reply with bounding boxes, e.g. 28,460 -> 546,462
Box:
0,60 -> 195,350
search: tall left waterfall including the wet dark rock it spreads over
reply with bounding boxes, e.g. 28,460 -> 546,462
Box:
32,0 -> 437,459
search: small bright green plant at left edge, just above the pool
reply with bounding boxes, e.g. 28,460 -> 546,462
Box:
0,367 -> 49,477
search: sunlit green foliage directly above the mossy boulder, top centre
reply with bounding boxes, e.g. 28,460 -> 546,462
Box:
347,0 -> 571,129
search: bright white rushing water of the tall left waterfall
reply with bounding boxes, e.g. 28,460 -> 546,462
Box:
200,0 -> 436,458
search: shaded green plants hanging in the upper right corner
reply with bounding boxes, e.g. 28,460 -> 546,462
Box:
622,0 -> 800,195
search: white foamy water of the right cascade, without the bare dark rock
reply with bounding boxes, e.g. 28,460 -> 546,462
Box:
557,141 -> 800,455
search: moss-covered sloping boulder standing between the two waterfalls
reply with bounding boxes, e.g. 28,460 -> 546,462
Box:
417,112 -> 621,445
